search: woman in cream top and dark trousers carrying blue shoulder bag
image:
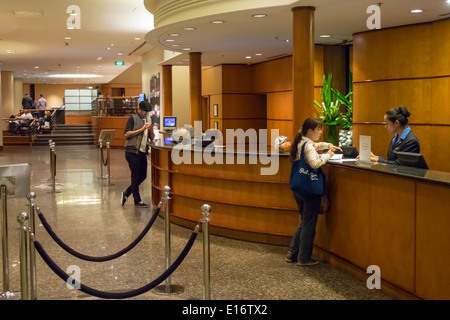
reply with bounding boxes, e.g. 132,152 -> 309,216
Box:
286,118 -> 342,266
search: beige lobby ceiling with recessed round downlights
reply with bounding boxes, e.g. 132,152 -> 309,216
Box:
0,0 -> 450,84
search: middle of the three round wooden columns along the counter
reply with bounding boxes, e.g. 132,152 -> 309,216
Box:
189,52 -> 202,125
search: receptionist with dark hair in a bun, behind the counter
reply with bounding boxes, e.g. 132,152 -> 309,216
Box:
371,107 -> 420,164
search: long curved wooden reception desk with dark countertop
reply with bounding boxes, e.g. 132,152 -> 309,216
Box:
151,141 -> 450,299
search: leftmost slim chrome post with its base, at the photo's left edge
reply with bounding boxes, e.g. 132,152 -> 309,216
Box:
0,185 -> 20,300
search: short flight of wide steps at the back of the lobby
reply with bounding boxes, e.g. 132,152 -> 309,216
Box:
33,124 -> 95,146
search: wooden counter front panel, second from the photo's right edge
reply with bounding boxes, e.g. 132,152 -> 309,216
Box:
368,174 -> 416,292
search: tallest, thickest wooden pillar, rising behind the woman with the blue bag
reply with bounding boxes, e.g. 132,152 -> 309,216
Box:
292,7 -> 316,137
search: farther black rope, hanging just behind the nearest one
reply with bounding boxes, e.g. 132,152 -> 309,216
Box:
37,207 -> 161,262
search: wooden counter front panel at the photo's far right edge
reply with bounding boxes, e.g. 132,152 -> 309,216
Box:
416,183 -> 450,299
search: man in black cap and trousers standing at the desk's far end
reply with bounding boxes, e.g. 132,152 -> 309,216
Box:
120,101 -> 154,208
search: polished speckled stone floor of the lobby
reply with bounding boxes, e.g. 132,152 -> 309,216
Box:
0,146 -> 390,300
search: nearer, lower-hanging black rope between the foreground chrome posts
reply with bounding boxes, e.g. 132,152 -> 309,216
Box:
34,232 -> 197,299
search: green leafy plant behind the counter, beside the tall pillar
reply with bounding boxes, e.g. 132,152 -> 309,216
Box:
314,74 -> 341,145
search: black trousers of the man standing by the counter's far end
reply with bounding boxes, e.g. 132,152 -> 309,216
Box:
124,152 -> 147,204
